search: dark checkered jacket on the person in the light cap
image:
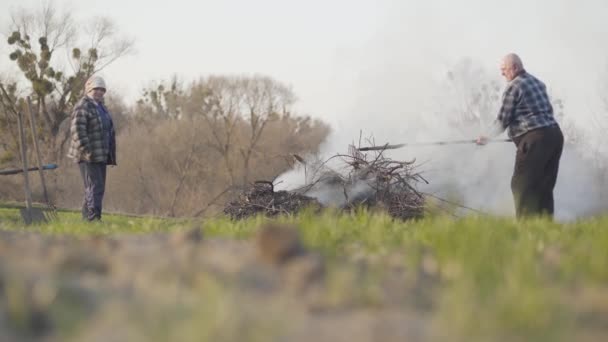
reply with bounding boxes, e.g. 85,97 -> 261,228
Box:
68,96 -> 116,165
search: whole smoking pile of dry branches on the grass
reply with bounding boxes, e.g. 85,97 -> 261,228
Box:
224,146 -> 426,220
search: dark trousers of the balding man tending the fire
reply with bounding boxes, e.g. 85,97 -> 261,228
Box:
511,126 -> 564,218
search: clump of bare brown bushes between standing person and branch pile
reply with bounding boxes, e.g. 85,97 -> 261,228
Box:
122,76 -> 329,216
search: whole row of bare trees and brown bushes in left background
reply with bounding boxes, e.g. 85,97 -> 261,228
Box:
0,4 -> 330,216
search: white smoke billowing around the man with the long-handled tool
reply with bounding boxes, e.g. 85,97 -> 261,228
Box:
279,0 -> 608,221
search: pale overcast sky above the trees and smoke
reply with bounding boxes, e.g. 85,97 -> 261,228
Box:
0,0 -> 608,127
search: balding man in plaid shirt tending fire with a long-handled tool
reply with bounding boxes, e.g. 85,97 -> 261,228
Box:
477,54 -> 564,218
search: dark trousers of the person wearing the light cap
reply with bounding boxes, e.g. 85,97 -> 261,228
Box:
78,162 -> 107,221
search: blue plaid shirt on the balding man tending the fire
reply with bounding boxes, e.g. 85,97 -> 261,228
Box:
493,72 -> 557,138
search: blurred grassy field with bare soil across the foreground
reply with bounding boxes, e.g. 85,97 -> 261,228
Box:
0,204 -> 608,341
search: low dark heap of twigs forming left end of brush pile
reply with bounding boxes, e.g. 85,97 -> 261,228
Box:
224,181 -> 321,220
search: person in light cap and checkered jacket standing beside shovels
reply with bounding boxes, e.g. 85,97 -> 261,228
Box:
68,76 -> 116,221
